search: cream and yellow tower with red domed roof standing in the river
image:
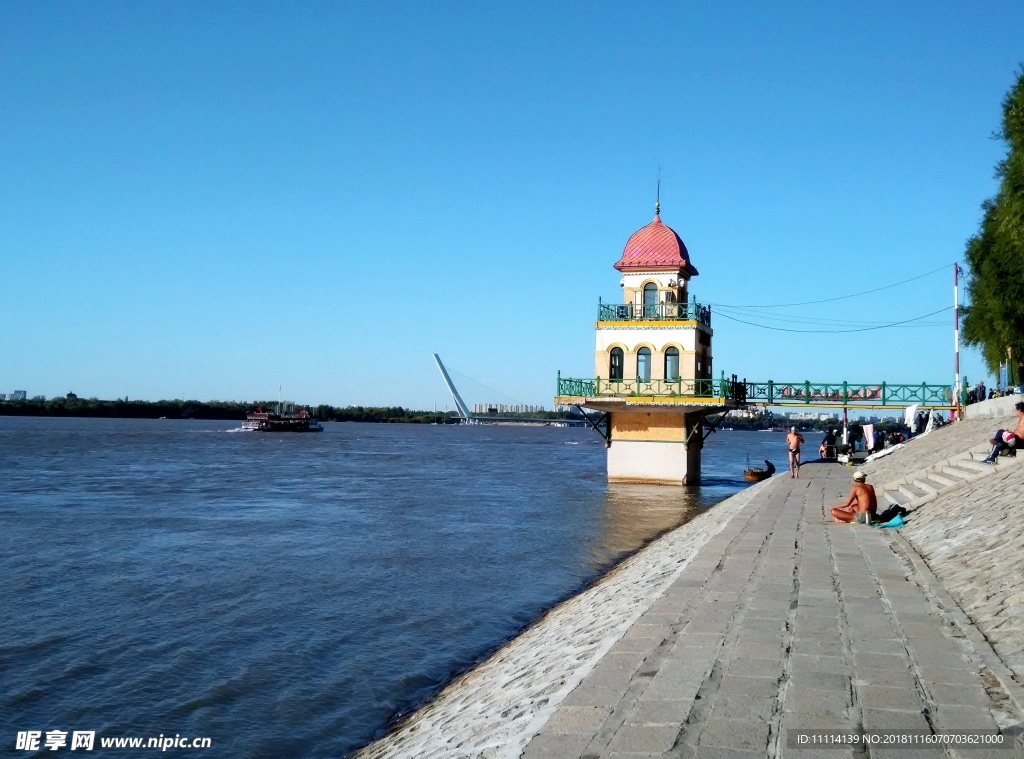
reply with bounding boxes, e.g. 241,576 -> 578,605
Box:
555,203 -> 743,484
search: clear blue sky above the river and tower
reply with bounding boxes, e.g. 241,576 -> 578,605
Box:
0,2 -> 1024,408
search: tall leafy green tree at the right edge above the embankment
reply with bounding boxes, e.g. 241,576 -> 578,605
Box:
964,67 -> 1024,382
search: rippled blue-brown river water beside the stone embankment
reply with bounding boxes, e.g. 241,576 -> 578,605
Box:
0,417 -> 785,758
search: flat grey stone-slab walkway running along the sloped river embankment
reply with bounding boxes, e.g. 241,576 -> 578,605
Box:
522,465 -> 1024,759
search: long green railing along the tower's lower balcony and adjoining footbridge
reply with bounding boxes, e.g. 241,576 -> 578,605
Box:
558,375 -> 952,406
